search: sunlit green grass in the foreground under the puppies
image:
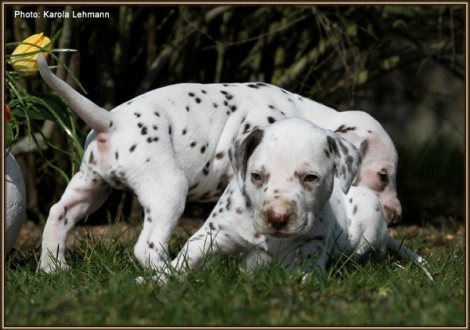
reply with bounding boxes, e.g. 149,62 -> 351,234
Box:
4,224 -> 466,326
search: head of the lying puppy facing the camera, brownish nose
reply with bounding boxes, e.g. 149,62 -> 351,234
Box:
229,118 -> 361,238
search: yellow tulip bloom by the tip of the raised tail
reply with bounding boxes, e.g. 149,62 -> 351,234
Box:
10,32 -> 52,76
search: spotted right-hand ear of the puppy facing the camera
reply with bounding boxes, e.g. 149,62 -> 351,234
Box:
326,133 -> 367,194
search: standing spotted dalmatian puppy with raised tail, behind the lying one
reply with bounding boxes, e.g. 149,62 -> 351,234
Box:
38,55 -> 401,272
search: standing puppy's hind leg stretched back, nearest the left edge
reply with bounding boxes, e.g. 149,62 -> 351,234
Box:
39,171 -> 110,273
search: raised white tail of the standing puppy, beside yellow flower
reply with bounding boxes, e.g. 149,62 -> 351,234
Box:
38,54 -> 112,132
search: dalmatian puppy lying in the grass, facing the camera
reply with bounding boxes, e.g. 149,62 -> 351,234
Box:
168,117 -> 423,281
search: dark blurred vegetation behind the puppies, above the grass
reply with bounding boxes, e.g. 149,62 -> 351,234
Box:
5,6 -> 465,227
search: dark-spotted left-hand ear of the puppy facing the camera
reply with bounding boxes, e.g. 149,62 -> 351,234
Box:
228,127 -> 264,187
